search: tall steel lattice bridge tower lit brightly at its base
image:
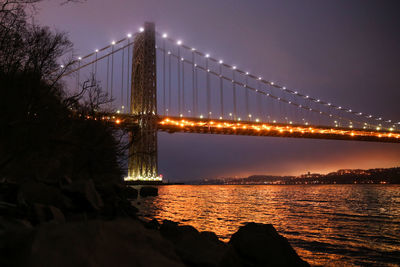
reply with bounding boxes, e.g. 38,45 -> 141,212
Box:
126,22 -> 161,181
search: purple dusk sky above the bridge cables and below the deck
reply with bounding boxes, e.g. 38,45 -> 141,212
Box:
36,0 -> 400,180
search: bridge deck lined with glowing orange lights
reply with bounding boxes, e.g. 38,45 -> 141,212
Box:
94,114 -> 400,143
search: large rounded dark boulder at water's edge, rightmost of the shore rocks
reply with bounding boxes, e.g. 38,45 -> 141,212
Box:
222,223 -> 309,266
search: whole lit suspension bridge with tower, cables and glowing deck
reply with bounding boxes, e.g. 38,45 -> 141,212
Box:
60,23 -> 400,181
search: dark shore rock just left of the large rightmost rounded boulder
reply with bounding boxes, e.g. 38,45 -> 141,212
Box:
160,220 -> 227,266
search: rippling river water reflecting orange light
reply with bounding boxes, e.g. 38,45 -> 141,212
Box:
139,185 -> 400,266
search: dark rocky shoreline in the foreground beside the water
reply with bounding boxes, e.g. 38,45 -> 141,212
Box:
0,179 -> 309,266
